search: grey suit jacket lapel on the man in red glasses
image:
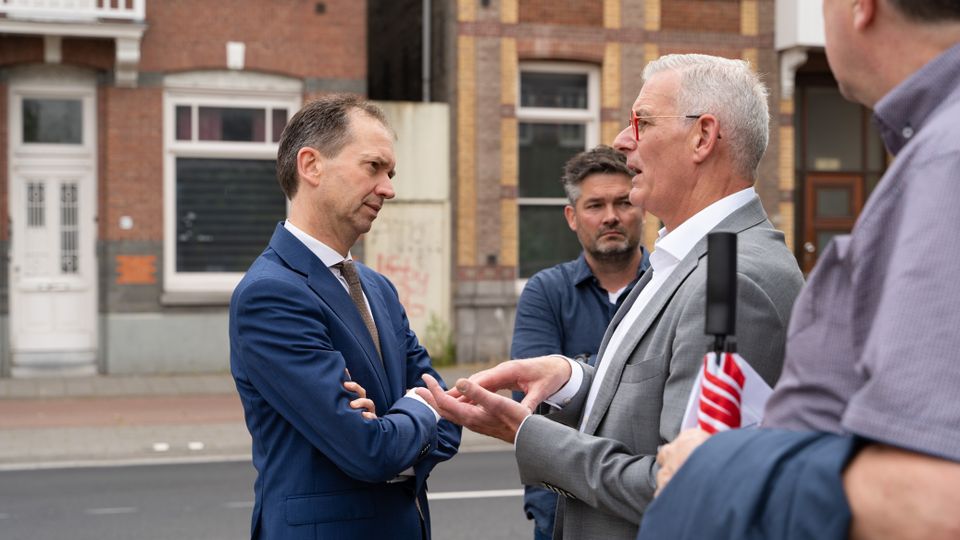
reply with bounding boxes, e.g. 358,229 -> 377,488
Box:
584,198 -> 767,435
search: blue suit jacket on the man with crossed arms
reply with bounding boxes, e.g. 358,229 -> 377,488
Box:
230,223 -> 460,539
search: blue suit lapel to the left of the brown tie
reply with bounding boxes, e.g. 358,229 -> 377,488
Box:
270,223 -> 390,395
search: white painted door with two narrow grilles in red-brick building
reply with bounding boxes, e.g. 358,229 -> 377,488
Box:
9,70 -> 97,377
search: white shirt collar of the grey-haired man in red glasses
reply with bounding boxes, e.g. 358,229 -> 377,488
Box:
650,187 -> 757,273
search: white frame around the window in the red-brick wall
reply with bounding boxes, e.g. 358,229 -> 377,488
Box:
163,72 -> 303,296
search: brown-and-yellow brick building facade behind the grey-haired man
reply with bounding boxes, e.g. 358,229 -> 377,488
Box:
451,0 -> 793,360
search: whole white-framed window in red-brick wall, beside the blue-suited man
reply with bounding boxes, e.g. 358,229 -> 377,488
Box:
164,73 -> 302,293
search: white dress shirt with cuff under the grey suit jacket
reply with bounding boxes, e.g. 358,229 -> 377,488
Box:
532,187 -> 757,432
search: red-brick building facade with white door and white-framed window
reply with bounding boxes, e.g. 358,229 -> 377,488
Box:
0,0 -> 367,376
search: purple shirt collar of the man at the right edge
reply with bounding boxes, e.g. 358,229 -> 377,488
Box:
874,44 -> 960,155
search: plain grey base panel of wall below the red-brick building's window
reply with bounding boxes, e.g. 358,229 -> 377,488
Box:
102,308 -> 230,375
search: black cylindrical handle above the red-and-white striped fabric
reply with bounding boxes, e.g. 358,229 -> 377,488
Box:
704,232 -> 737,353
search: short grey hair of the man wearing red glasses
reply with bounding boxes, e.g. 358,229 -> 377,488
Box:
643,54 -> 770,181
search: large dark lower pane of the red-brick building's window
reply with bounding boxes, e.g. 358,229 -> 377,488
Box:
176,158 -> 286,272
